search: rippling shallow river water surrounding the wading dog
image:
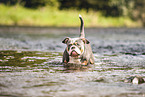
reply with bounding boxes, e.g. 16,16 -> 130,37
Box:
0,27 -> 145,97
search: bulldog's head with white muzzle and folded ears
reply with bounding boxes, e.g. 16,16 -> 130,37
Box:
62,37 -> 90,57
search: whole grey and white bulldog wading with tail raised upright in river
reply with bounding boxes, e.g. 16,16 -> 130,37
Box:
62,15 -> 94,65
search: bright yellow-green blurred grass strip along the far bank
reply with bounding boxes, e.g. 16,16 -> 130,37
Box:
0,5 -> 141,27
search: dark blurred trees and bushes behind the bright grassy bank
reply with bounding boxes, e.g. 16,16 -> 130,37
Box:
0,0 -> 145,27
